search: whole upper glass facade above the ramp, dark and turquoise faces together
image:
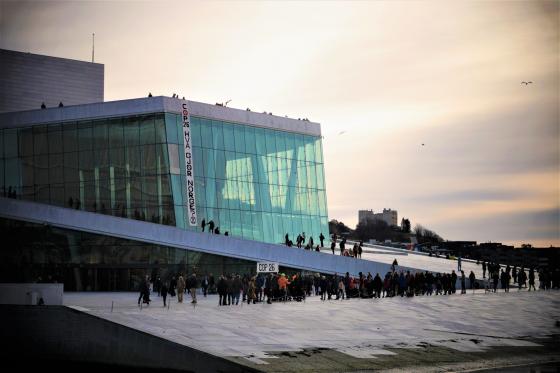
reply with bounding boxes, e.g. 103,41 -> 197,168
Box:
0,109 -> 328,243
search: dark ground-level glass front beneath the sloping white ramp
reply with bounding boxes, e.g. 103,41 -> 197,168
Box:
0,219 -> 256,291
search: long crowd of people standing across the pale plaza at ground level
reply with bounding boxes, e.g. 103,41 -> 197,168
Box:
138,260 -> 560,306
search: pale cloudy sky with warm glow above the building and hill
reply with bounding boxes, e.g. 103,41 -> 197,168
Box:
0,0 -> 560,247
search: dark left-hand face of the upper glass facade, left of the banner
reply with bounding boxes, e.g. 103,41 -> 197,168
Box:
0,114 -> 175,225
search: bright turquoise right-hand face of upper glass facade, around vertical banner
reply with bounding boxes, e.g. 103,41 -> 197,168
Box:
165,114 -> 328,243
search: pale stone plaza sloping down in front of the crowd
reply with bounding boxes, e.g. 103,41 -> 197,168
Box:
64,290 -> 560,364
